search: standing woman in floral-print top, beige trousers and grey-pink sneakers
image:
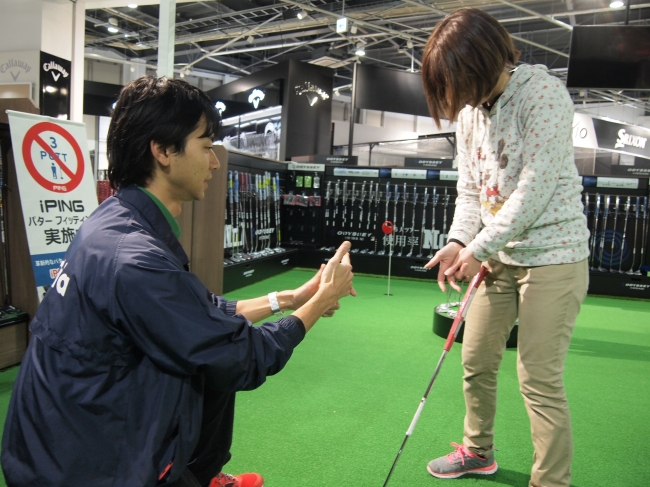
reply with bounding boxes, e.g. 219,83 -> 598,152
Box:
422,8 -> 589,487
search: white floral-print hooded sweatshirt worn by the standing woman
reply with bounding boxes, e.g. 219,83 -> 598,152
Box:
448,65 -> 589,267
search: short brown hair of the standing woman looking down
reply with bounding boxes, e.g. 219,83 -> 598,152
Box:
422,8 -> 521,128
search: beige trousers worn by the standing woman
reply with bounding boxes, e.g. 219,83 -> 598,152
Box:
462,260 -> 589,487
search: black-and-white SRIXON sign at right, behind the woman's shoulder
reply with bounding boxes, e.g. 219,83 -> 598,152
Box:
573,113 -> 650,159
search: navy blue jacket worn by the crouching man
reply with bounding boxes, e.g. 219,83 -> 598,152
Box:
2,186 -> 305,487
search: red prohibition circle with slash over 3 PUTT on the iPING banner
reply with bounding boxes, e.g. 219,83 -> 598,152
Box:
23,122 -> 85,193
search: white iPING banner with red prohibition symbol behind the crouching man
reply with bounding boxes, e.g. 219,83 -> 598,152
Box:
7,110 -> 98,292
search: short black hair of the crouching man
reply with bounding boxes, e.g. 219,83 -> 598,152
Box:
106,76 -> 221,189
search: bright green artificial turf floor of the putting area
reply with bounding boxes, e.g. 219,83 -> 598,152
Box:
0,270 -> 650,487
